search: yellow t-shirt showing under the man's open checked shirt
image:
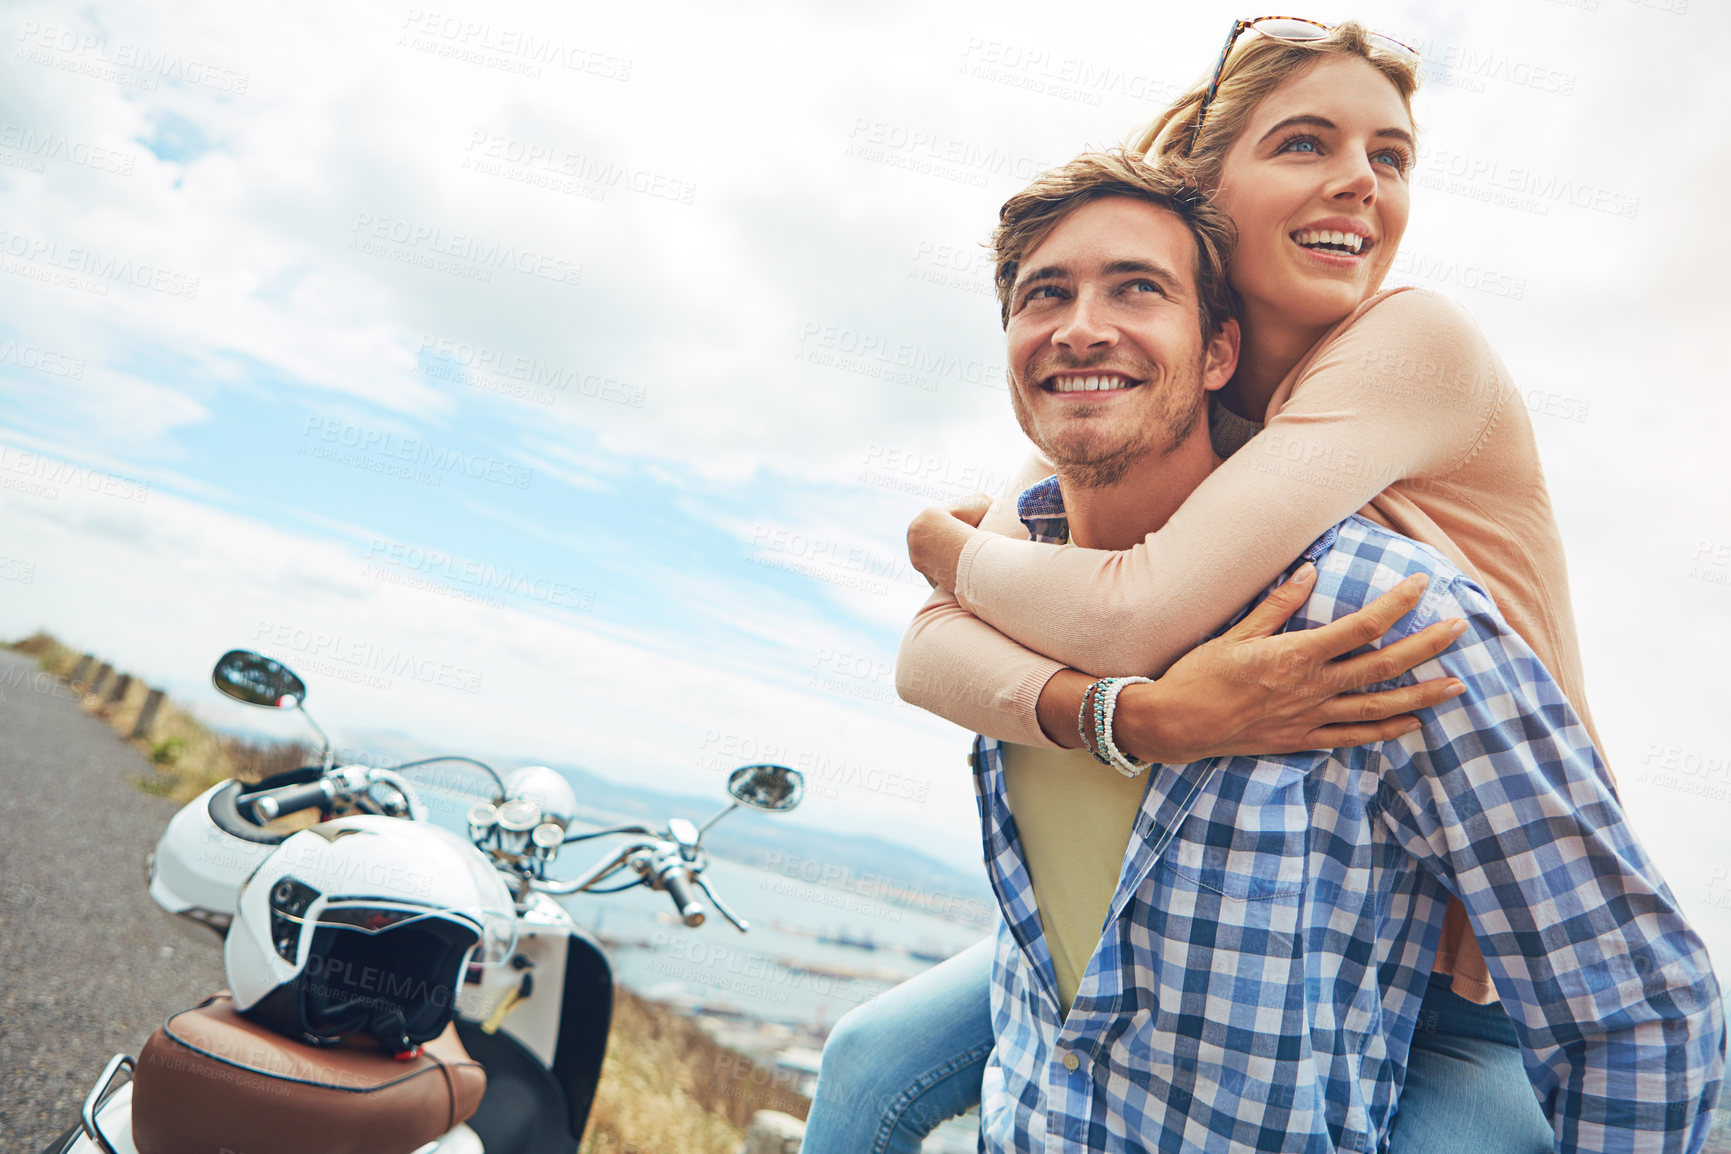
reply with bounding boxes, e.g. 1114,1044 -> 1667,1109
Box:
1002,742 -> 1148,1014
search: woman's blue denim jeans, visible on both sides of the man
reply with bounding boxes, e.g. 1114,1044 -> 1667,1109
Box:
801,938 -> 1554,1154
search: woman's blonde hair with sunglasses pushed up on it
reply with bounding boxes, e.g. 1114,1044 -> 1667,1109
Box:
1127,21 -> 1418,192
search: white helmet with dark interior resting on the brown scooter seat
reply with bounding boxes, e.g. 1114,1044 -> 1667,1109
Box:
225,815 -> 516,1055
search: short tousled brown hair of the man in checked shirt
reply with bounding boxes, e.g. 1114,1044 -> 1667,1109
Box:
990,149 -> 1238,339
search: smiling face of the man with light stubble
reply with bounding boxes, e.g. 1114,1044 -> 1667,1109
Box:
1006,197 -> 1232,488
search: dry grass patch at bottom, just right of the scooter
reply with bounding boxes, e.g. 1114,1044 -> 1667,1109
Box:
580,990 -> 810,1154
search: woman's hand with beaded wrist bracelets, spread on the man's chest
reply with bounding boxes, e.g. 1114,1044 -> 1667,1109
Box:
1040,566 -> 1466,765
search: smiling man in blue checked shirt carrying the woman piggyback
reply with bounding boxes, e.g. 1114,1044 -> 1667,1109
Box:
973,154 -> 1724,1152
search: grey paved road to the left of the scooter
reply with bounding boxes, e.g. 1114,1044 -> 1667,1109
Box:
0,651 -> 223,1154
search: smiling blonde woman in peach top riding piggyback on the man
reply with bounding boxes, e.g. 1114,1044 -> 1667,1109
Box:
805,19 -> 1591,1154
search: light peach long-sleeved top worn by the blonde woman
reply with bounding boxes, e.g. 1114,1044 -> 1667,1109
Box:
897,289 -> 1603,1002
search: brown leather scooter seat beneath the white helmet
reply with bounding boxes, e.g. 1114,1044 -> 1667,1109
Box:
132,991 -> 486,1154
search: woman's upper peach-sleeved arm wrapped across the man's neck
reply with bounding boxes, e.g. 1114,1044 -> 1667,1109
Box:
956,292 -> 1504,675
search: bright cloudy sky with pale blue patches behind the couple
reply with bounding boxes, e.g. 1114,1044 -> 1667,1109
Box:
0,0 -> 1731,958
